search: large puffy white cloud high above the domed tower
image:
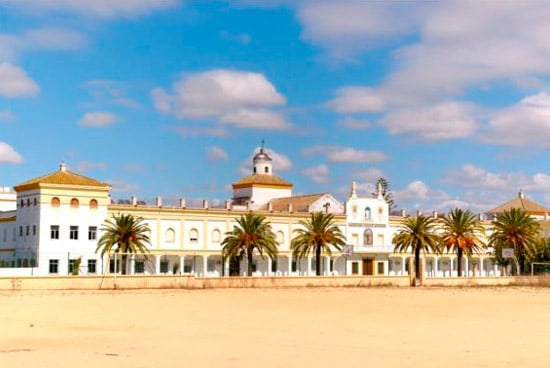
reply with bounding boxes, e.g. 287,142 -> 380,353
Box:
151,69 -> 291,130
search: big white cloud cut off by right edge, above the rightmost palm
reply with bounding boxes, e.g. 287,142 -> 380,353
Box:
481,92 -> 550,148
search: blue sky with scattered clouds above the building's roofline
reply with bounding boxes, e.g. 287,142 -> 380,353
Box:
0,0 -> 550,212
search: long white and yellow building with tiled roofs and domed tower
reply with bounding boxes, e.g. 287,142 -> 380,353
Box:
0,147 -> 548,277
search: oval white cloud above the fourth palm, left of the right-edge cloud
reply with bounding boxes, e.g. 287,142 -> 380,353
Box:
379,101 -> 477,141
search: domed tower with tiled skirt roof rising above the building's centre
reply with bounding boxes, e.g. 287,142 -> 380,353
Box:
233,142 -> 292,209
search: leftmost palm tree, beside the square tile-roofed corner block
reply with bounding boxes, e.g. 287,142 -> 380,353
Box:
96,214 -> 151,275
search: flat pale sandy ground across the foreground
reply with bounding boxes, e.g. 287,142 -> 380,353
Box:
0,288 -> 550,368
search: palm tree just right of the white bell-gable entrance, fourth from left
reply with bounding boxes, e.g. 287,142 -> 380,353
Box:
392,216 -> 440,279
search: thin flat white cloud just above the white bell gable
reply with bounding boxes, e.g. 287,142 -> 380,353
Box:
302,145 -> 387,163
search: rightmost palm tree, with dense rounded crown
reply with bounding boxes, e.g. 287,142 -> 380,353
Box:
489,208 -> 540,274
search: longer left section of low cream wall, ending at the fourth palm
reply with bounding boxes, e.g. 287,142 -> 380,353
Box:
0,275 -> 409,291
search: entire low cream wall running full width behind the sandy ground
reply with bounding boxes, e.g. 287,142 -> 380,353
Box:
0,275 -> 550,291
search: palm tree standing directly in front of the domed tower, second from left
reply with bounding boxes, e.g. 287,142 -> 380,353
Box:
222,212 -> 278,276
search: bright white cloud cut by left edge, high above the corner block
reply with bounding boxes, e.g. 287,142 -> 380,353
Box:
0,63 -> 40,98
